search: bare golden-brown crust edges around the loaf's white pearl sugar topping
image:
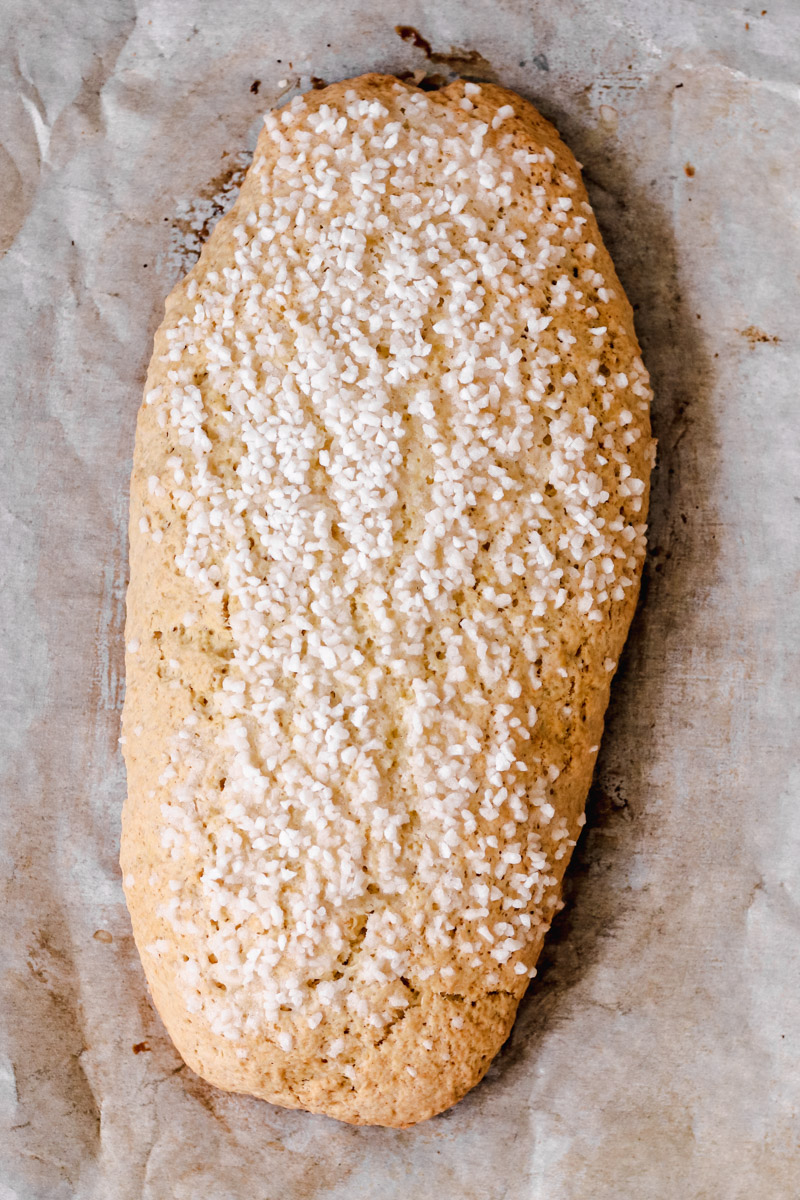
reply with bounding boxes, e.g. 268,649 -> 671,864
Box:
121,74 -> 651,1127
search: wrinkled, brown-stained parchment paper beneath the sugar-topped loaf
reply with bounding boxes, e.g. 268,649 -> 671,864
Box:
0,0 -> 800,1200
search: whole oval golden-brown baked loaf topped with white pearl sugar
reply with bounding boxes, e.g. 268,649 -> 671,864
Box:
121,74 -> 654,1126
